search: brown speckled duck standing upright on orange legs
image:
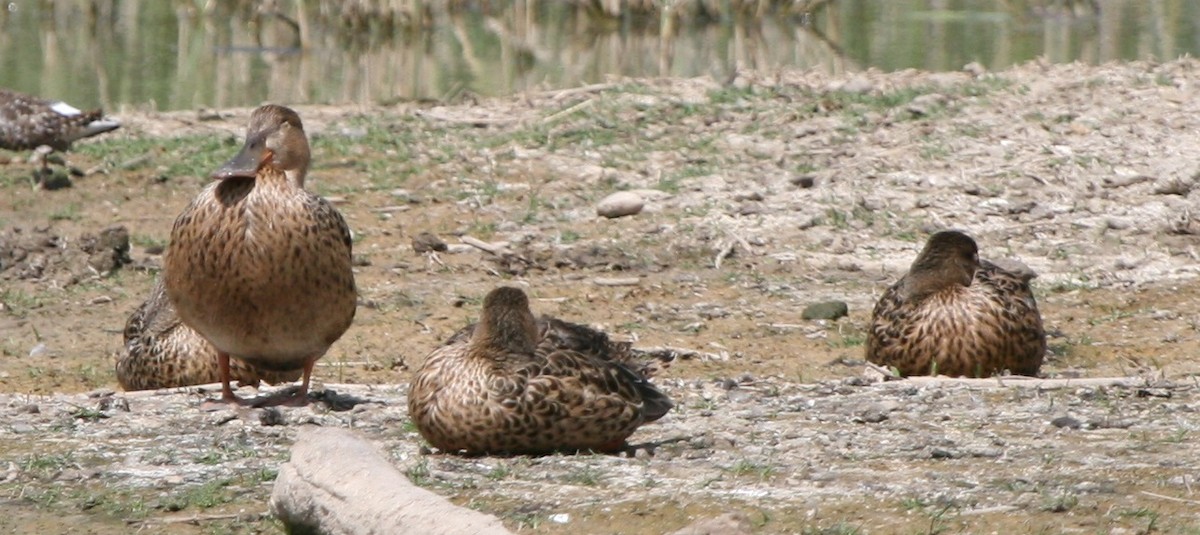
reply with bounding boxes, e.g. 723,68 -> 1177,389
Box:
163,104 -> 358,405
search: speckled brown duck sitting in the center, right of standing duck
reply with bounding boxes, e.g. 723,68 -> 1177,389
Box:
408,287 -> 672,455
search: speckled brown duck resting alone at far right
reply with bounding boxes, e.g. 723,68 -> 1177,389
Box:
866,230 -> 1046,377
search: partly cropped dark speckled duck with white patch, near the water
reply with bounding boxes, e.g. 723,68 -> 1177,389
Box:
0,89 -> 120,150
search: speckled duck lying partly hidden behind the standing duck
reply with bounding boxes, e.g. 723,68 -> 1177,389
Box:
116,281 -> 300,390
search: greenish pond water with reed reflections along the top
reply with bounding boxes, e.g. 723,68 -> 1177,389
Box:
0,0 -> 1200,112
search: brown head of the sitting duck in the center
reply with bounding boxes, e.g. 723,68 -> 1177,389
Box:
472,287 -> 538,354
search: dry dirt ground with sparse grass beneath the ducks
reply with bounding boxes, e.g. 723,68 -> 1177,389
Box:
0,60 -> 1200,534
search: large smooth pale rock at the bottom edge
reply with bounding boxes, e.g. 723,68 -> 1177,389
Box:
271,427 -> 511,535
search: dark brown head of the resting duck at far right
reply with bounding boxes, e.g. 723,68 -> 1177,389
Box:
904,230 -> 979,299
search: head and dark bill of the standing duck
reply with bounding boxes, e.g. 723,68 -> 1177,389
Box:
212,104 -> 311,187
